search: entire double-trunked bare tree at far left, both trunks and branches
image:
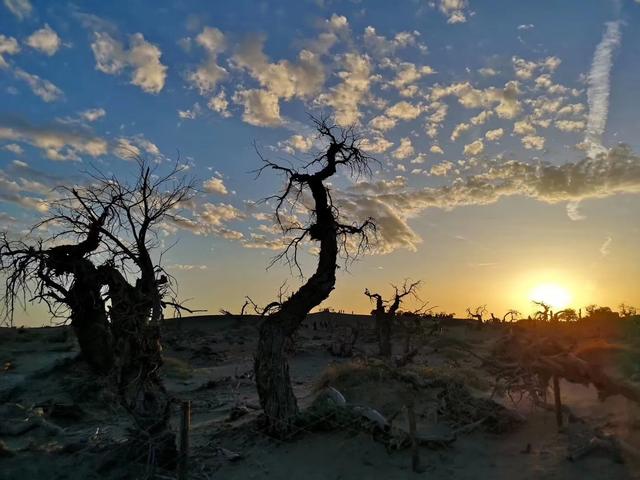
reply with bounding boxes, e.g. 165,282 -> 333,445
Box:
0,159 -> 194,464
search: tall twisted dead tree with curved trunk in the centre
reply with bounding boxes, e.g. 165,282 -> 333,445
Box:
254,119 -> 375,437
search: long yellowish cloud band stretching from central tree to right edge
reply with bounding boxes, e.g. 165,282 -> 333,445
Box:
335,146 -> 640,252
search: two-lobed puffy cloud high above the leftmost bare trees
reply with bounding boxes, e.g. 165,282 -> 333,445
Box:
91,32 -> 167,94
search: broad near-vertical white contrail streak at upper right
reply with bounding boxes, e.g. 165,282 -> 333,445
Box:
585,21 -> 621,156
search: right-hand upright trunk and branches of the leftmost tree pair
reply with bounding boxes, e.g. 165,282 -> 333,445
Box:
66,159 -> 194,457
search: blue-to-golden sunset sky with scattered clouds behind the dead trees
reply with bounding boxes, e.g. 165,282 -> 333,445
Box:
0,0 -> 640,324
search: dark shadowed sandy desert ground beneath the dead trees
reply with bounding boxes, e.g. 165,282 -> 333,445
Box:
0,315 -> 640,480
